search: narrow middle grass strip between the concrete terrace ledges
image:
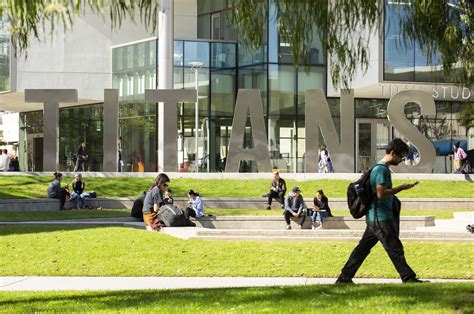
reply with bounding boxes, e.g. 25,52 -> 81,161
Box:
0,209 -> 458,221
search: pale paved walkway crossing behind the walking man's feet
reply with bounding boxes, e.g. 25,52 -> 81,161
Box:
0,276 -> 474,291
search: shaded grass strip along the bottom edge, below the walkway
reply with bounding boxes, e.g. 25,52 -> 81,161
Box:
0,283 -> 474,313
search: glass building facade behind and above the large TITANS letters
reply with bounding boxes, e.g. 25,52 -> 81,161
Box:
15,0 -> 472,173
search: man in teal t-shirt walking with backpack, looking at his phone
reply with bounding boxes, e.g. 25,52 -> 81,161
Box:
336,138 -> 423,284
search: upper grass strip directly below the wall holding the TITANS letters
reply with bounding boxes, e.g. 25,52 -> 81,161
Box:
0,175 -> 474,199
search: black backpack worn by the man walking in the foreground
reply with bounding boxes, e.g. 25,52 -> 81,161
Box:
347,164 -> 386,219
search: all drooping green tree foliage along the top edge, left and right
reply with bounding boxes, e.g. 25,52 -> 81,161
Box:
0,0 -> 474,88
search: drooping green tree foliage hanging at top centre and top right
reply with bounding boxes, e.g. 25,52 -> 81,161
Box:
229,0 -> 474,88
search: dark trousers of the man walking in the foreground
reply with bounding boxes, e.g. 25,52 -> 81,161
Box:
341,220 -> 416,282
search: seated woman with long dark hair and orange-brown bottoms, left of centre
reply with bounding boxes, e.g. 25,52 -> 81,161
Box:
142,173 -> 170,231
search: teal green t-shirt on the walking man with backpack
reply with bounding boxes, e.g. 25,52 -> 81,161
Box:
366,160 -> 393,221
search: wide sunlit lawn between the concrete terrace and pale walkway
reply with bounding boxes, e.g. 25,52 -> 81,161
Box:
0,226 -> 474,278
